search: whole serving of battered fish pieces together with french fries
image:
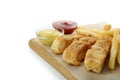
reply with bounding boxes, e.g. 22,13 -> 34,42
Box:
51,23 -> 120,73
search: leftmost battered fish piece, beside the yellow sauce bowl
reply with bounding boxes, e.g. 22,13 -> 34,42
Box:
51,34 -> 83,54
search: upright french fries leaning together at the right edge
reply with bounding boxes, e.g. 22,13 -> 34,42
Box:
108,30 -> 120,70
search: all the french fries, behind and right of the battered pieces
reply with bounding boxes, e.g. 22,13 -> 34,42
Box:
76,24 -> 120,70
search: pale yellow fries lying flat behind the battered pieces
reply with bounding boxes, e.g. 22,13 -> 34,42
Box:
76,24 -> 116,37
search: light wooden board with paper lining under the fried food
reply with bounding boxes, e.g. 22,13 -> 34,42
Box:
29,38 -> 120,80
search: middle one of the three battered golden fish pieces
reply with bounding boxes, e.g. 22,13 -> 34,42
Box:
62,36 -> 96,65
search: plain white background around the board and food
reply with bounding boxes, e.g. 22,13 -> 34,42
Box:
0,0 -> 120,80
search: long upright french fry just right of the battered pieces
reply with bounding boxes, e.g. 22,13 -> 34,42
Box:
108,31 -> 119,70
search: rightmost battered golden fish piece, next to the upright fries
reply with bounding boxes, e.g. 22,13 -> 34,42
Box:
84,36 -> 112,73
